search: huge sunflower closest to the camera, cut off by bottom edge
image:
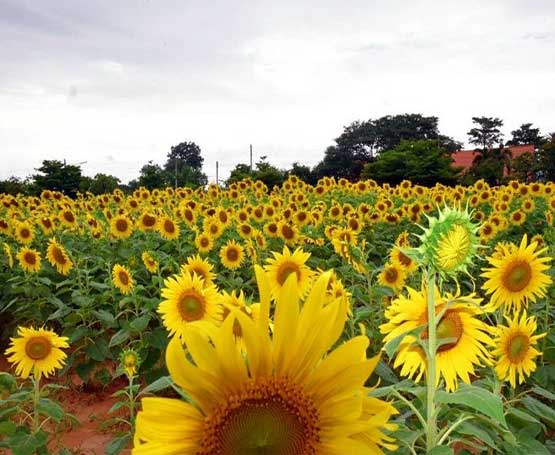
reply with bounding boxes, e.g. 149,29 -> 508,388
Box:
132,267 -> 396,455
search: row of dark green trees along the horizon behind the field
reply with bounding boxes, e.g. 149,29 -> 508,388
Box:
0,114 -> 555,196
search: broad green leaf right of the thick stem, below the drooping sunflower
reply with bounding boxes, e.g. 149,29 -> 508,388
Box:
436,384 -> 507,428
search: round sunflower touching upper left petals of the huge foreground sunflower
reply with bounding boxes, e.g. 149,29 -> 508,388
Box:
158,271 -> 223,338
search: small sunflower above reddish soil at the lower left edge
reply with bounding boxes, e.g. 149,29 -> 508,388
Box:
5,327 -> 69,379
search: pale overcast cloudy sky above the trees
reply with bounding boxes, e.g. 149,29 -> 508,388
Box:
0,0 -> 555,182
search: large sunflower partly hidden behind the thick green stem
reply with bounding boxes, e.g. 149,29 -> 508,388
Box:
380,287 -> 492,391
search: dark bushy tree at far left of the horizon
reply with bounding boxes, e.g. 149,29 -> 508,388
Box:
32,160 -> 82,197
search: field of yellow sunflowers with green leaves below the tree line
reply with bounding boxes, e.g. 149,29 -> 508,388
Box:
0,177 -> 555,455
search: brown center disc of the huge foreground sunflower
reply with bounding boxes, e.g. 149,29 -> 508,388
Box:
202,379 -> 319,455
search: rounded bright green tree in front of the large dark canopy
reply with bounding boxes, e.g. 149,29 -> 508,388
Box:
361,139 -> 460,186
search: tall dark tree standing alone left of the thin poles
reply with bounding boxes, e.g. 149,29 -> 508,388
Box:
164,142 -> 208,188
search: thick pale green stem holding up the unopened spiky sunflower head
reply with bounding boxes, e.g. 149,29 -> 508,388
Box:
426,270 -> 437,452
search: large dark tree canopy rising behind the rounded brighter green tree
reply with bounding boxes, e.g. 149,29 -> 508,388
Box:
314,114 -> 462,180
